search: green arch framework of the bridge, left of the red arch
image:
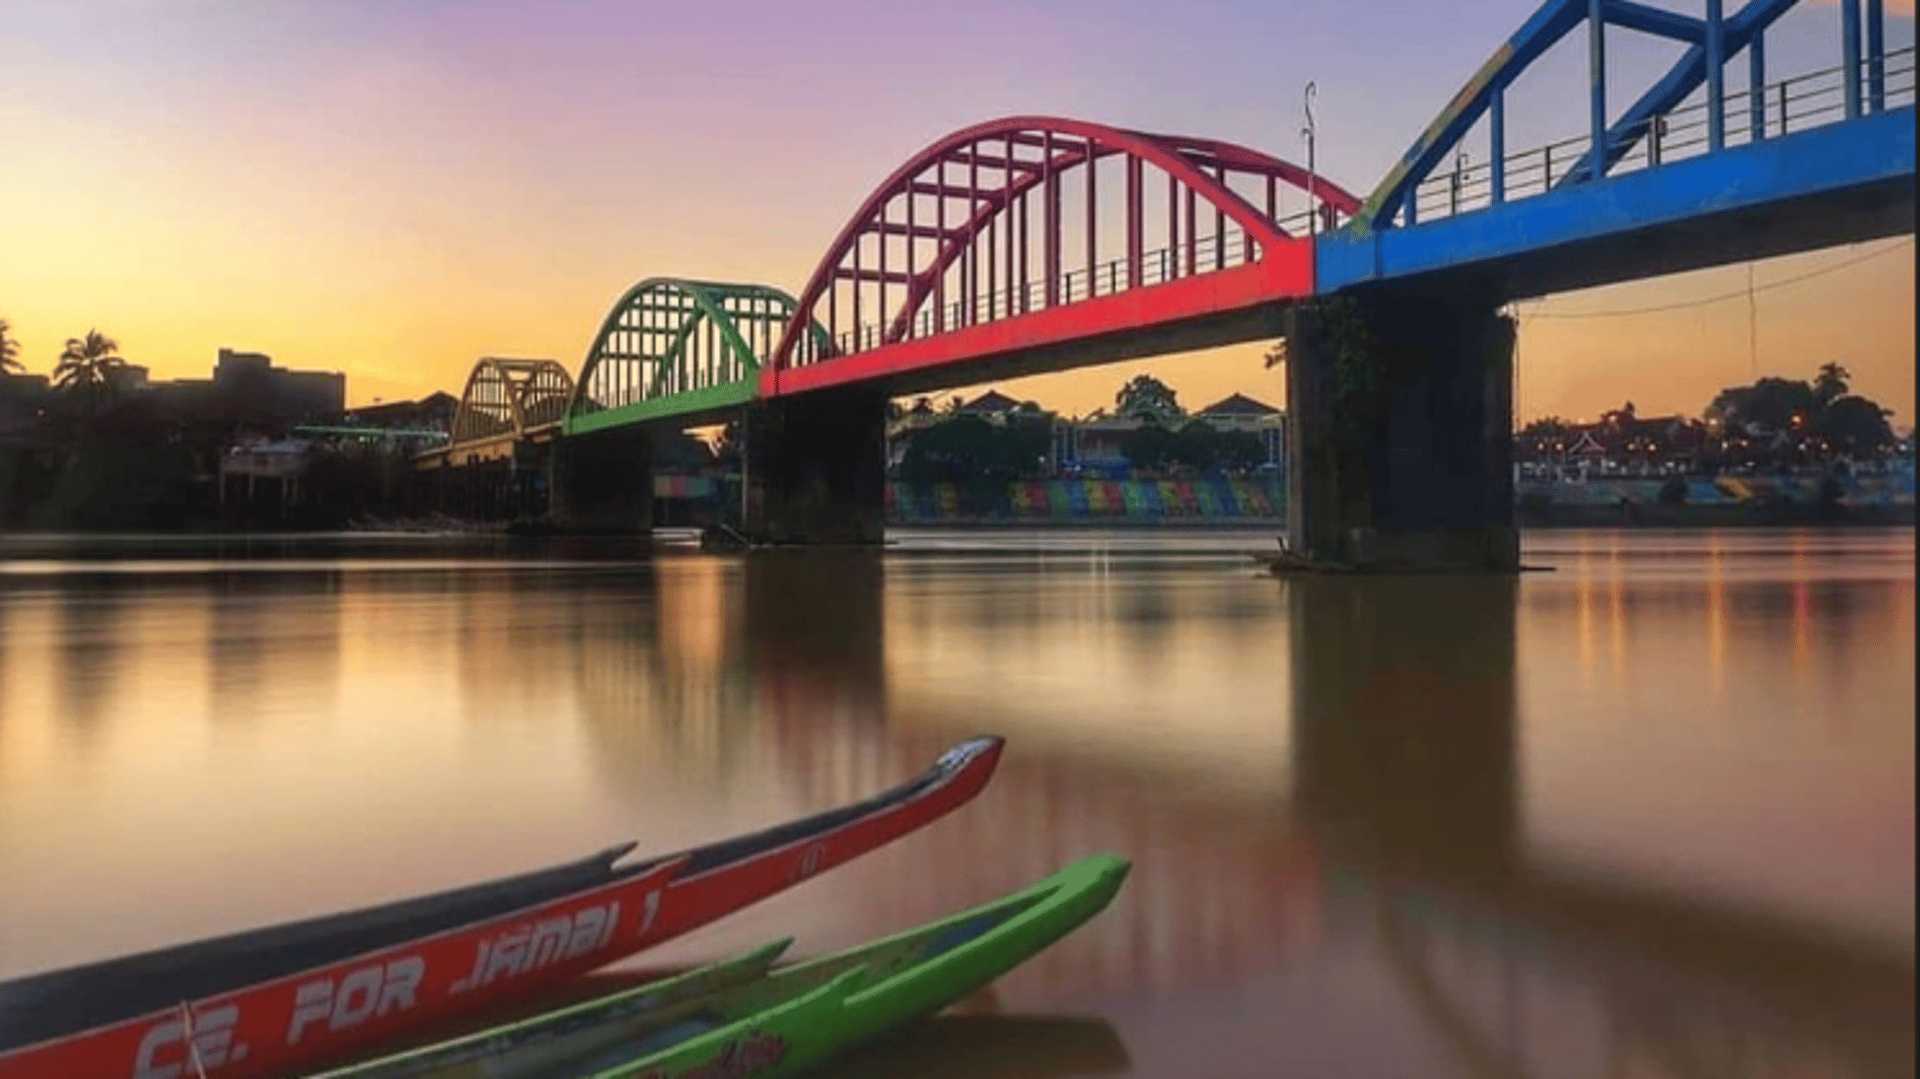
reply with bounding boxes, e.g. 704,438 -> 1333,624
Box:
566,276 -> 828,434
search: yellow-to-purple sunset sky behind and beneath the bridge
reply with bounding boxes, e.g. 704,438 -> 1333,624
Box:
0,0 -> 1914,424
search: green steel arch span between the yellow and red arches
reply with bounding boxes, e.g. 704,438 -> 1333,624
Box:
566,276 -> 821,434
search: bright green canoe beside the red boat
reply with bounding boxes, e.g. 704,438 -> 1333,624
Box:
313,854 -> 1129,1079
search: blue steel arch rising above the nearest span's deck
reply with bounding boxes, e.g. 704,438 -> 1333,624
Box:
1352,0 -> 1799,232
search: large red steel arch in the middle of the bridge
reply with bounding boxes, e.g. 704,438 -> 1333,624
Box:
770,115 -> 1359,376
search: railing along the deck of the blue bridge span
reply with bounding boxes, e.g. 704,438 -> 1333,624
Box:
1413,46 -> 1914,223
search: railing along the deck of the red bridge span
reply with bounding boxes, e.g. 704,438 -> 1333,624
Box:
817,205 -> 1346,355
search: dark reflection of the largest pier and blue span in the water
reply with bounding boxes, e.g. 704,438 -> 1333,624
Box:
1288,578 -> 1914,1077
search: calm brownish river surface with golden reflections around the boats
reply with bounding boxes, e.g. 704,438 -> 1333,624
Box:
0,530 -> 1914,1079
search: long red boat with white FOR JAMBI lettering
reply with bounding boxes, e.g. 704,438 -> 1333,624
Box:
0,737 -> 1002,1079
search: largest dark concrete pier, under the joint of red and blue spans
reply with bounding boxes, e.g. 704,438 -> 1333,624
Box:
1286,284 -> 1521,572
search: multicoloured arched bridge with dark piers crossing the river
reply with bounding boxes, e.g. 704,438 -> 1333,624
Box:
420,0 -> 1914,556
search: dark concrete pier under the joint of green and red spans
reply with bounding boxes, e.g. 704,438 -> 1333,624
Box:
741,390 -> 887,545
